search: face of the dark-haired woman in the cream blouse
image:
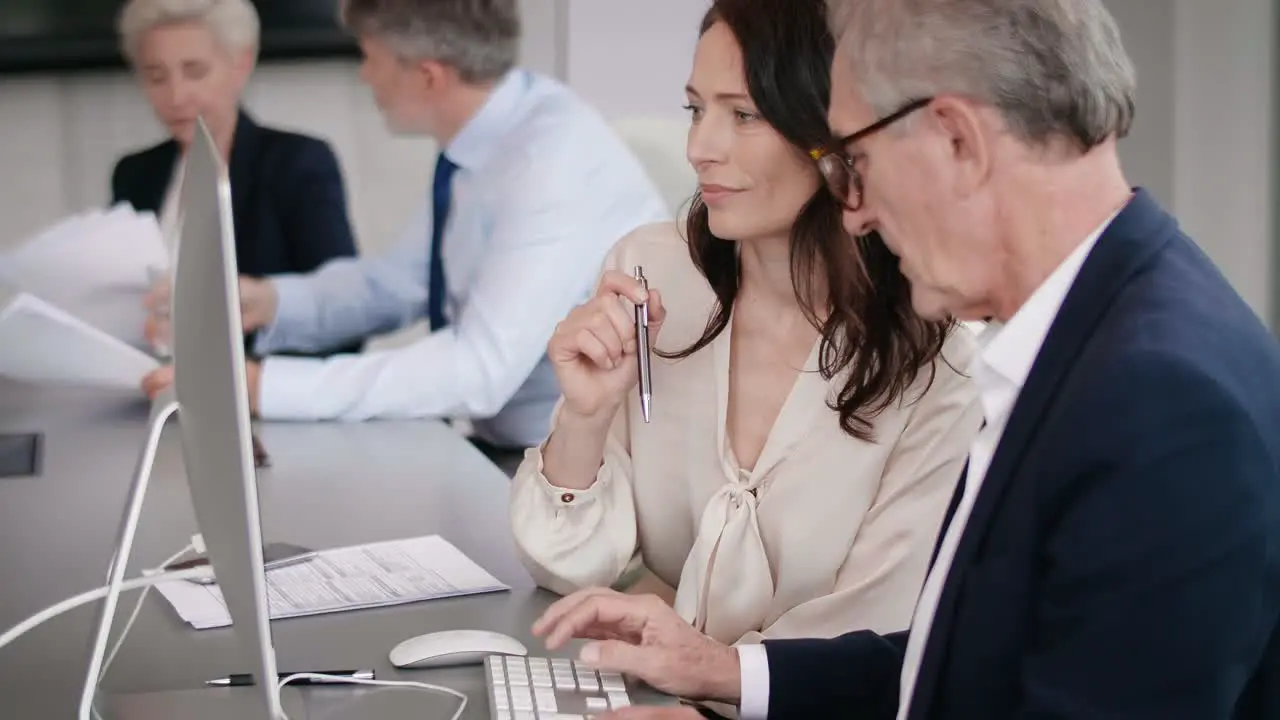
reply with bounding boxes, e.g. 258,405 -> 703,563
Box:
686,23 -> 820,241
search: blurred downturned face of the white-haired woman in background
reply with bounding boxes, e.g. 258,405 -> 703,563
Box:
136,22 -> 253,150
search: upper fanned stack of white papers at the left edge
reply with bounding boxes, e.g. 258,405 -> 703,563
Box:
0,205 -> 170,347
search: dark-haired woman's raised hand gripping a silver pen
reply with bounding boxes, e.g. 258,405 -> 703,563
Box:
547,270 -> 667,424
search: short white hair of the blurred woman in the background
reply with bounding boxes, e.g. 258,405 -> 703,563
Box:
116,0 -> 261,63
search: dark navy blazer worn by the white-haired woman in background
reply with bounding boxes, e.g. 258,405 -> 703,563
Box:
111,111 -> 360,351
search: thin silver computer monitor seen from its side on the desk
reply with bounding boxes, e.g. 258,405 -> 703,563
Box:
172,116 -> 283,720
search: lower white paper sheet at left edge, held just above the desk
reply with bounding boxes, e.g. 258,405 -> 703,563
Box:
0,293 -> 159,389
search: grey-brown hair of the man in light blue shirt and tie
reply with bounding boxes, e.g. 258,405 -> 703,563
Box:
340,0 -> 521,82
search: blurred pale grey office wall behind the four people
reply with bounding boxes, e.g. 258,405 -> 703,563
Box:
0,0 -> 1280,338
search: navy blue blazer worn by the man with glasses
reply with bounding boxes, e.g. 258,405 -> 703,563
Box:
764,190 -> 1280,720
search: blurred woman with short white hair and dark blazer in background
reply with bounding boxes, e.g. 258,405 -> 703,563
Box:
111,0 -> 356,351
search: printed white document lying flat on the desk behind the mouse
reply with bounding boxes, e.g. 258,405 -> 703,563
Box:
156,536 -> 511,630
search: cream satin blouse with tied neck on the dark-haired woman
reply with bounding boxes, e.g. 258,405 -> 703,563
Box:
511,223 -> 982,643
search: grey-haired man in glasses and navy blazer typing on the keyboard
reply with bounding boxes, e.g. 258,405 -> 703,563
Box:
534,0 -> 1280,720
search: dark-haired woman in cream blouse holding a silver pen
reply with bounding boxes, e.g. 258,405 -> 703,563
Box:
511,0 -> 982,643
